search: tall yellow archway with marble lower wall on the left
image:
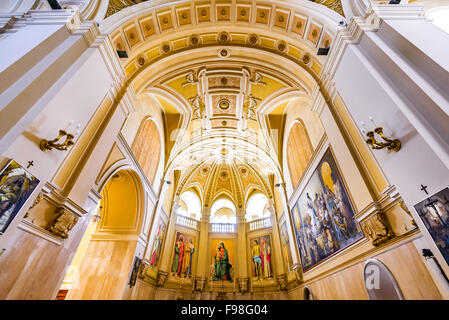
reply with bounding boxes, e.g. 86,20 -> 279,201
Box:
61,169 -> 144,300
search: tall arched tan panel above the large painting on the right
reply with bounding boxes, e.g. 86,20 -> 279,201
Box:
287,120 -> 313,188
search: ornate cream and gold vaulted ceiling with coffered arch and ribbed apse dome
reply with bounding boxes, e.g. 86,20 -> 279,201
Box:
100,0 -> 332,208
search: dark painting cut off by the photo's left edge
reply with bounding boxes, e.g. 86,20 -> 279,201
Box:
0,160 -> 39,234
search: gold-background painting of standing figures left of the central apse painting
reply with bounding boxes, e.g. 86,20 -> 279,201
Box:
171,232 -> 195,278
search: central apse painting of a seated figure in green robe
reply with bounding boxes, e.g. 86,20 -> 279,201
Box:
210,239 -> 234,282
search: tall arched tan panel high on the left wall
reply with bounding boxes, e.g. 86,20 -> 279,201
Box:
131,118 -> 161,183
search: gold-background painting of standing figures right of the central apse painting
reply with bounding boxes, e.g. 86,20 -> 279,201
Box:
250,235 -> 273,279
